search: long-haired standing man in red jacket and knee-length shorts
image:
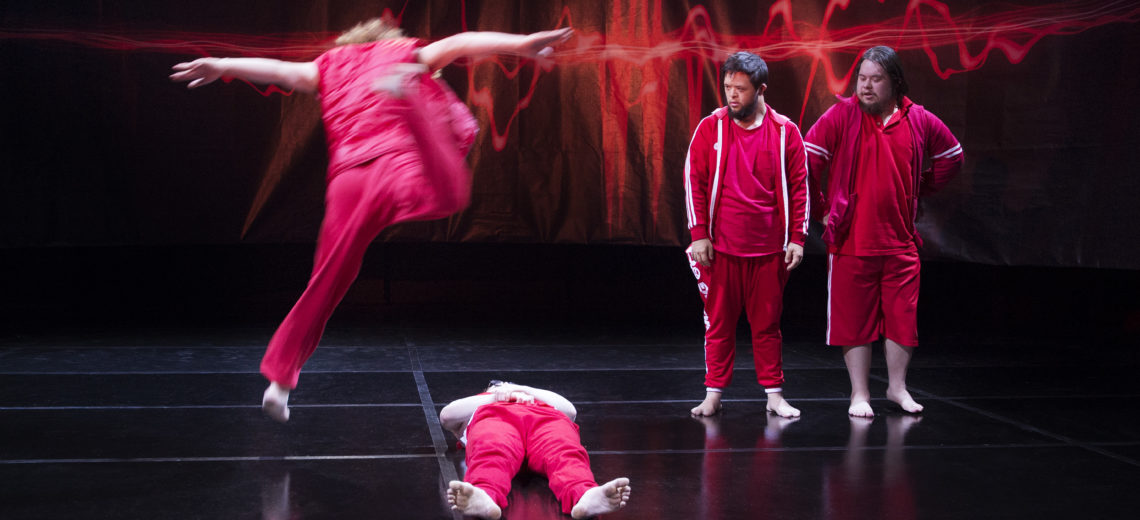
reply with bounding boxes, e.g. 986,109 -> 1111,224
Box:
805,47 -> 963,417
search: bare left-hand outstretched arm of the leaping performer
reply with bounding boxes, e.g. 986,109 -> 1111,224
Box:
170,58 -> 320,94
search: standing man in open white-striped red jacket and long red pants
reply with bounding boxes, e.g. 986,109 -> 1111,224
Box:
685,51 -> 808,417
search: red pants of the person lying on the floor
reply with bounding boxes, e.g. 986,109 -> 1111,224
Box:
463,401 -> 597,514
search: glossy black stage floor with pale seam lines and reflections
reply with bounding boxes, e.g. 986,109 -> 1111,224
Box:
0,324 -> 1140,520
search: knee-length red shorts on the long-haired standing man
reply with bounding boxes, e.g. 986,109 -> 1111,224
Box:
828,252 -> 921,347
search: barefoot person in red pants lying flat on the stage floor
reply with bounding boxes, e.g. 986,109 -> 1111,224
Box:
439,381 -> 630,519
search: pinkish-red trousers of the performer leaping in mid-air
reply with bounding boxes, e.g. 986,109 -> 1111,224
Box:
261,97 -> 471,388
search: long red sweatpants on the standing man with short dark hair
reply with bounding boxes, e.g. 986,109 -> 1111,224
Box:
686,251 -> 788,391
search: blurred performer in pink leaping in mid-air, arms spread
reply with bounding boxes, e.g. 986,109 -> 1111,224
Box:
170,18 -> 572,422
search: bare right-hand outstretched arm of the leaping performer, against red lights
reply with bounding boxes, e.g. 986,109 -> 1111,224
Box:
420,27 -> 573,71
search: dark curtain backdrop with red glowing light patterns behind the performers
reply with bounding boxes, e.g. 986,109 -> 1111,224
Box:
0,0 -> 1140,269
